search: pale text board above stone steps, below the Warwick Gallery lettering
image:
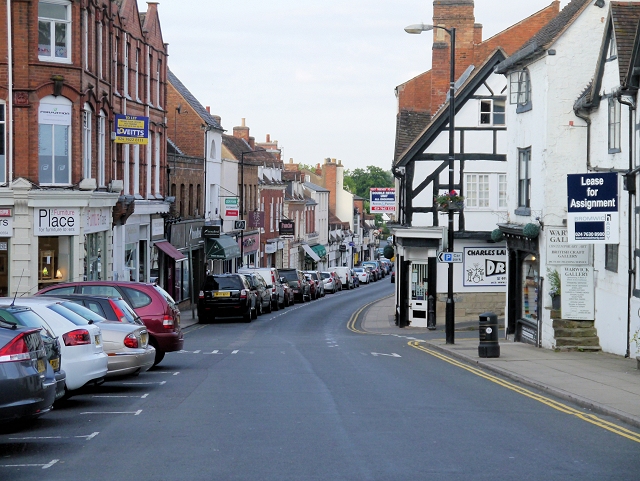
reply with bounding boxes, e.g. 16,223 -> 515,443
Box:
560,266 -> 595,321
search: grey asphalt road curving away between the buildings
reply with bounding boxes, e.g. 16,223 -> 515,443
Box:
0,278 -> 640,481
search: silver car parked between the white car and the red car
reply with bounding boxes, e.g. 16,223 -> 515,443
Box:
62,300 -> 156,378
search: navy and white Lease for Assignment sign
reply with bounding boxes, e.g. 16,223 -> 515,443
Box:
567,172 -> 620,244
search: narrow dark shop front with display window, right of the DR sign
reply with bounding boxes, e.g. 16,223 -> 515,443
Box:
498,224 -> 542,346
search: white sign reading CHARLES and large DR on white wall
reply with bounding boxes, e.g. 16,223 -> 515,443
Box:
463,246 -> 507,287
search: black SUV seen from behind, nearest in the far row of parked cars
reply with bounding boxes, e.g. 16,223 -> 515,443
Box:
198,274 -> 257,323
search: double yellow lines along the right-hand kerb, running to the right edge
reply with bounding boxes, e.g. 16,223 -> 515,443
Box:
409,341 -> 640,443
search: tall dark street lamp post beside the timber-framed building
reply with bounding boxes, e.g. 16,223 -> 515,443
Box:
404,23 -> 456,344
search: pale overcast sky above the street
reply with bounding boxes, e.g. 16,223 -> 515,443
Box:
138,0 -> 568,169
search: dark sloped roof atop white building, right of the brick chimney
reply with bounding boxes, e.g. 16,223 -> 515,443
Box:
495,0 -> 592,74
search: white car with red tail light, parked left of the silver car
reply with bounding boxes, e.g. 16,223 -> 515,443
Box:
0,296 -> 107,397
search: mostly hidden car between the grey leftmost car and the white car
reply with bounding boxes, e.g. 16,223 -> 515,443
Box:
0,305 -> 67,400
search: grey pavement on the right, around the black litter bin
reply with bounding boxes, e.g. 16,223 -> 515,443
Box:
180,297 -> 640,428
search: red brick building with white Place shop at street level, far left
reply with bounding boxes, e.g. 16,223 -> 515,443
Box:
0,0 -> 169,295
